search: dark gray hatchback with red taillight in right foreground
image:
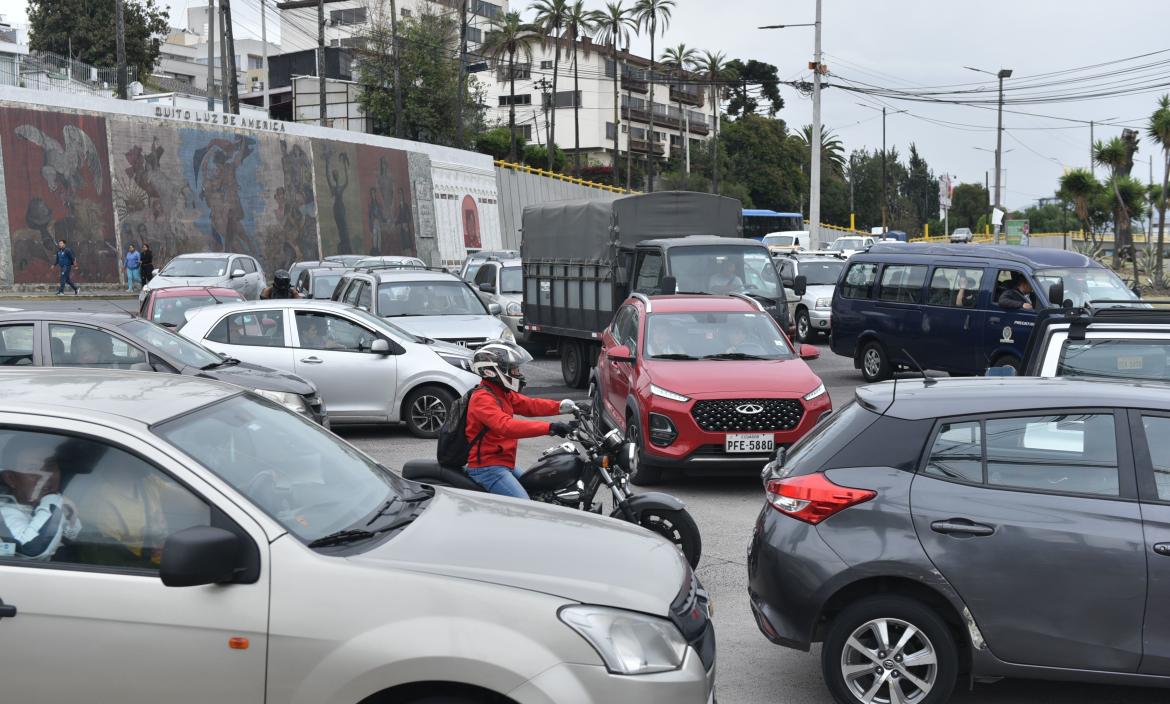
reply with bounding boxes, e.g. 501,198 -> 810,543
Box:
748,378 -> 1170,704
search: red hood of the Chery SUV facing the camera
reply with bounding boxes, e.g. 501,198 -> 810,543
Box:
647,359 -> 820,398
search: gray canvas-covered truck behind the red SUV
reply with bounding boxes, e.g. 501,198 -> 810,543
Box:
521,191 -> 790,388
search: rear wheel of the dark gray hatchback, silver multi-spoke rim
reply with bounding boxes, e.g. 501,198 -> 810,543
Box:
820,595 -> 959,704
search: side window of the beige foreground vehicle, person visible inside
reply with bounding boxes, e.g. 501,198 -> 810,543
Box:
0,429 -> 211,571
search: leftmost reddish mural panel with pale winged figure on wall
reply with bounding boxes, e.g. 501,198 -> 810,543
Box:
0,108 -> 118,283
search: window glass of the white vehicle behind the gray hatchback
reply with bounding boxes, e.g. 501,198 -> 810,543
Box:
1057,339 -> 1170,381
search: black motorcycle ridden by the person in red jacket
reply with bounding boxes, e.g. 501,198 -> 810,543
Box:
402,407 -> 703,567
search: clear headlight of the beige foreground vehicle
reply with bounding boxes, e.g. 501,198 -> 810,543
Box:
557,606 -> 687,675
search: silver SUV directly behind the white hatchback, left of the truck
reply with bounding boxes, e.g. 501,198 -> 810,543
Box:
332,269 -> 516,348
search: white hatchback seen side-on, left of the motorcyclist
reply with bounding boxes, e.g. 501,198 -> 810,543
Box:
179,298 -> 480,437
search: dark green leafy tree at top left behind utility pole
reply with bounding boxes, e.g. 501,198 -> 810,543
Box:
27,0 -> 170,81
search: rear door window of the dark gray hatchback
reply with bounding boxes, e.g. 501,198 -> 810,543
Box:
985,414 -> 1119,496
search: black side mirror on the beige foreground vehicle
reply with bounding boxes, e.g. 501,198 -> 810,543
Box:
158,525 -> 243,587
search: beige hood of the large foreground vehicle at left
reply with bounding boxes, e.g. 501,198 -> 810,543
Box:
350,489 -> 687,616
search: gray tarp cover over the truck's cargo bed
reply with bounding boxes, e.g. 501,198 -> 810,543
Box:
519,191 -> 743,264
